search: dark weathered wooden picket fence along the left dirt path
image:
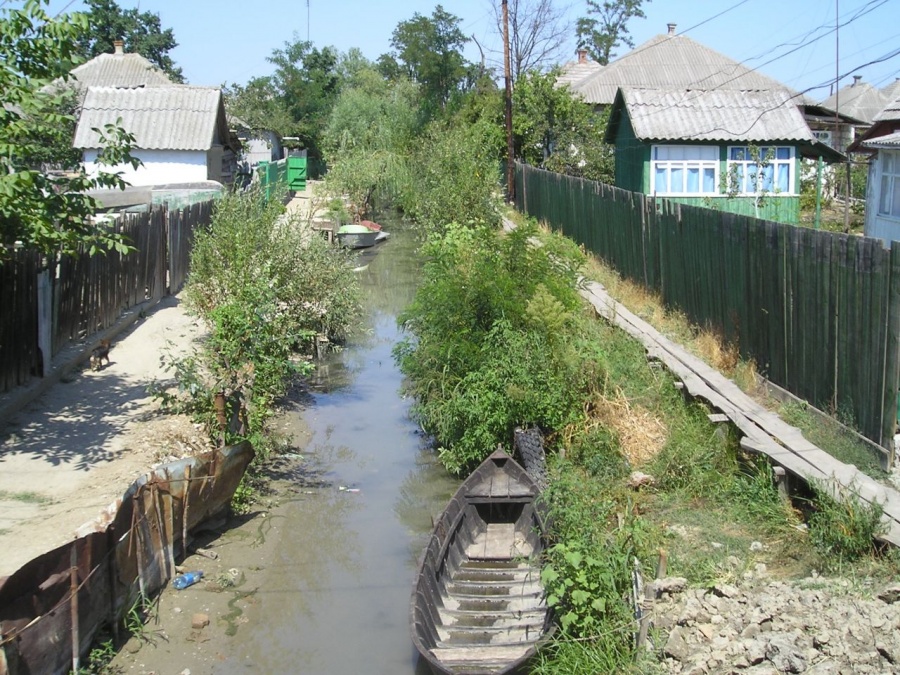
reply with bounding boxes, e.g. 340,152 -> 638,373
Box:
0,202 -> 212,393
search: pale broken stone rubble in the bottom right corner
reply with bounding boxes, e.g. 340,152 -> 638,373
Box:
648,565 -> 900,675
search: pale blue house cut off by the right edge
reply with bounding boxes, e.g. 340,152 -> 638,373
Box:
850,94 -> 900,242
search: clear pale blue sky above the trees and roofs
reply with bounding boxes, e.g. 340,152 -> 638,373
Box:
42,0 -> 900,100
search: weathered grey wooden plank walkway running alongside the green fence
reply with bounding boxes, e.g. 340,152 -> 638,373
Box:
581,282 -> 900,546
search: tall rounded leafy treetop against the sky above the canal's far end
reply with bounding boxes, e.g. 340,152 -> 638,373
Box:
379,5 -> 470,109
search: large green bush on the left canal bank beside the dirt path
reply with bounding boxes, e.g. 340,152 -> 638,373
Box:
157,187 -> 361,450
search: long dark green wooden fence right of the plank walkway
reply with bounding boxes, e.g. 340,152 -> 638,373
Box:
516,164 -> 900,451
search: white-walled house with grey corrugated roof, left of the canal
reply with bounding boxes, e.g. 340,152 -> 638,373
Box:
74,85 -> 239,185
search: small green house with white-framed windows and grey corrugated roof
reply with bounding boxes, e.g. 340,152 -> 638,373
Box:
606,87 -> 834,223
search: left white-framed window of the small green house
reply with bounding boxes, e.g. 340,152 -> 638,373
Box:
650,145 -> 719,195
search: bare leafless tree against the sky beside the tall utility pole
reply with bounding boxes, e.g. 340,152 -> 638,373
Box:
494,0 -> 571,82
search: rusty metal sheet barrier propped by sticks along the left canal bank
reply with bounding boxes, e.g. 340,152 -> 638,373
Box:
0,442 -> 253,675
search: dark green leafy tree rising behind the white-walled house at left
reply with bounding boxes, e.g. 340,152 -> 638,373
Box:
78,0 -> 184,82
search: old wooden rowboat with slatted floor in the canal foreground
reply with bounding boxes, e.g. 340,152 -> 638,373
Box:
410,450 -> 555,675
